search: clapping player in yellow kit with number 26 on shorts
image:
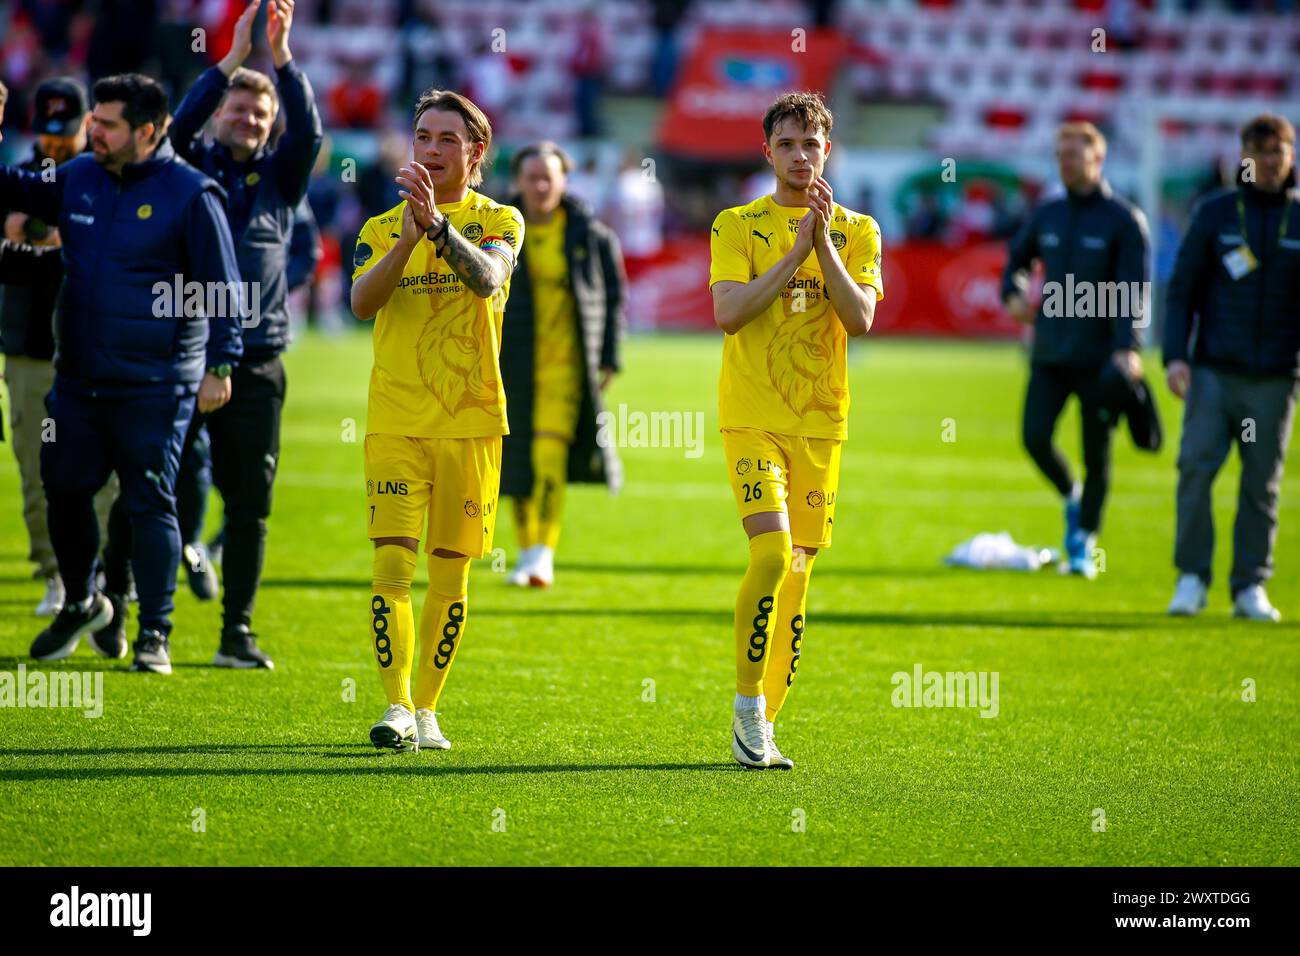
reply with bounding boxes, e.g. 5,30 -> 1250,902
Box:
710,92 -> 884,769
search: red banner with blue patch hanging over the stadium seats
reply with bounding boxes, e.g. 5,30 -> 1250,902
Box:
659,29 -> 848,161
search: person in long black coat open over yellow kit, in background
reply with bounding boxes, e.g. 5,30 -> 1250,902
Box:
501,143 -> 625,587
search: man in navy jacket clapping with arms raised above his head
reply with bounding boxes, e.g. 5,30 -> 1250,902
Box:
95,0 -> 324,669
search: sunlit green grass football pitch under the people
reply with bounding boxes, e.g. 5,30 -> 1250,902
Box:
0,336 -> 1300,865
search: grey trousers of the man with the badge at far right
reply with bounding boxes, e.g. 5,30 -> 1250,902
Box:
1174,365 -> 1300,594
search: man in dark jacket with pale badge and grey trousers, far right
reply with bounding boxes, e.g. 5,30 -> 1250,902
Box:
1165,113 -> 1300,620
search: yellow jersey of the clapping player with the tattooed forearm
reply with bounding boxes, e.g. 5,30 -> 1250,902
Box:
352,190 -> 524,438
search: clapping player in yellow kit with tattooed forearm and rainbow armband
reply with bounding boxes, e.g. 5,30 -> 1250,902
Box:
352,90 -> 524,750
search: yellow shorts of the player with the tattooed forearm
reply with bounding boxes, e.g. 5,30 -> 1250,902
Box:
365,433 -> 501,558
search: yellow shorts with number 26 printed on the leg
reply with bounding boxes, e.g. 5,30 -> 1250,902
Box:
722,428 -> 844,548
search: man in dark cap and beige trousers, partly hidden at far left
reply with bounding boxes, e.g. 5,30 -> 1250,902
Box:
0,77 -> 117,618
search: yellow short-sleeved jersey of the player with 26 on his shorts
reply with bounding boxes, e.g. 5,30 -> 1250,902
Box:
709,195 -> 884,440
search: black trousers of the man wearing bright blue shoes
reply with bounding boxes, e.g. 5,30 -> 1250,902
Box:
1022,363 -> 1114,533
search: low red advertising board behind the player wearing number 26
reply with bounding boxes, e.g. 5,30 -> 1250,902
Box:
629,237 -> 1022,338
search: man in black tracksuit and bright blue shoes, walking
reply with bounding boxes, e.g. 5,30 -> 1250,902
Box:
1002,122 -> 1151,578
